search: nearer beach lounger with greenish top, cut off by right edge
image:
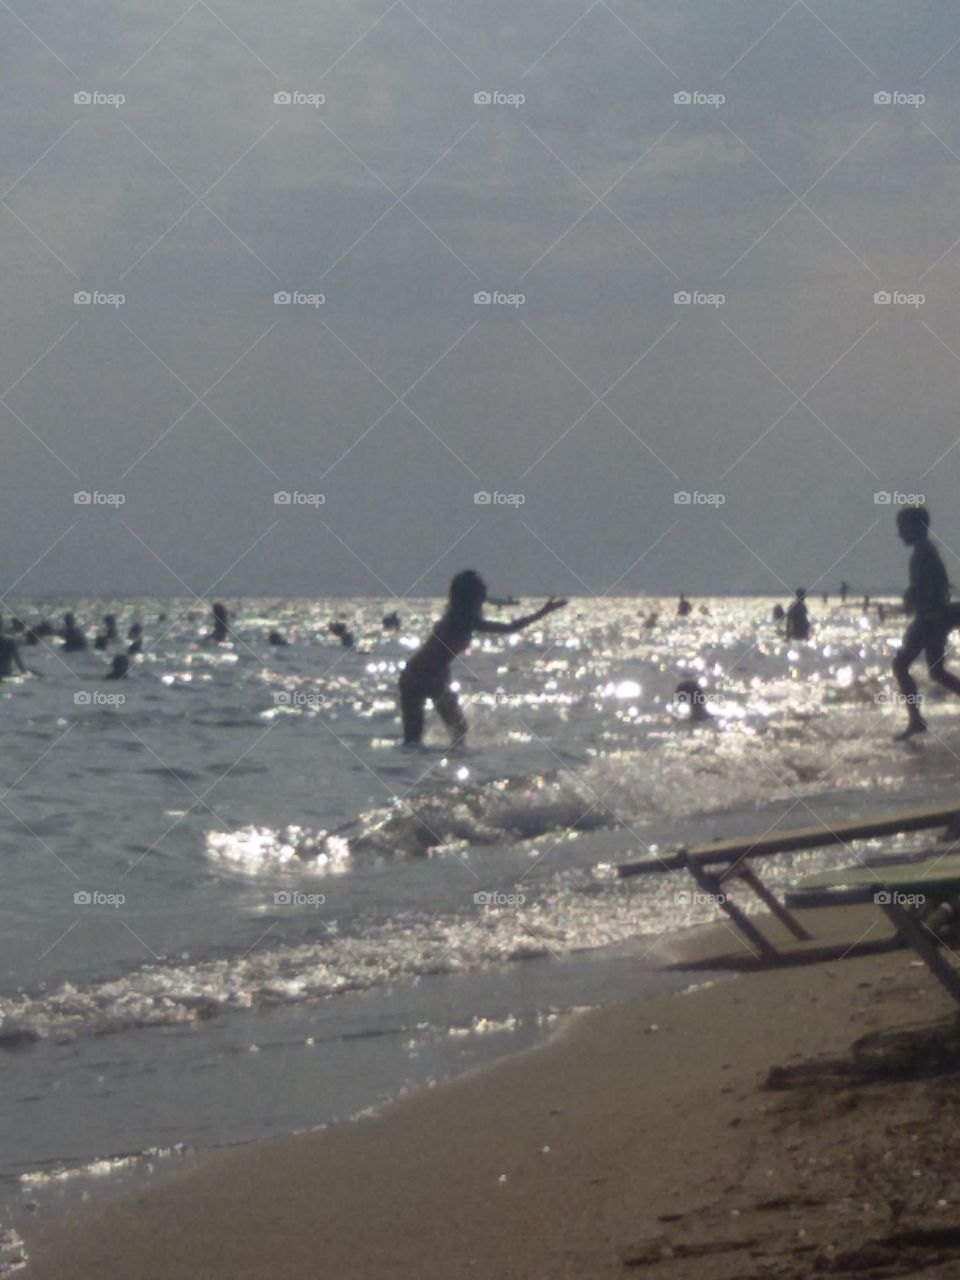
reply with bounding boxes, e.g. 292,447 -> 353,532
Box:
786,854 -> 960,1002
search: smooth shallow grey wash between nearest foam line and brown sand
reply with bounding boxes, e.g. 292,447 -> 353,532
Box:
0,924 -> 709,1182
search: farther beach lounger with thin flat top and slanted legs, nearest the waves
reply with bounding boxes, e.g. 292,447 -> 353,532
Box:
617,805 -> 960,960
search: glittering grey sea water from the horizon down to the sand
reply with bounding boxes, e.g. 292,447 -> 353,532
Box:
0,598 -> 960,1223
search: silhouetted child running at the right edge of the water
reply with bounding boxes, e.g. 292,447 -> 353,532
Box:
893,507 -> 960,742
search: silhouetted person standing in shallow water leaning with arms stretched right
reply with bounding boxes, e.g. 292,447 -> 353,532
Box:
399,568 -> 567,746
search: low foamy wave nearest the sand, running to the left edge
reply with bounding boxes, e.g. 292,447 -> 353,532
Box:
0,877 -> 686,1050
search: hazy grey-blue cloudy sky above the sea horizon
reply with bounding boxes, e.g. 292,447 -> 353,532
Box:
0,0 -> 960,598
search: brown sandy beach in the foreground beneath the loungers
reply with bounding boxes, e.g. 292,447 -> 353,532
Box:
20,913 -> 960,1280
